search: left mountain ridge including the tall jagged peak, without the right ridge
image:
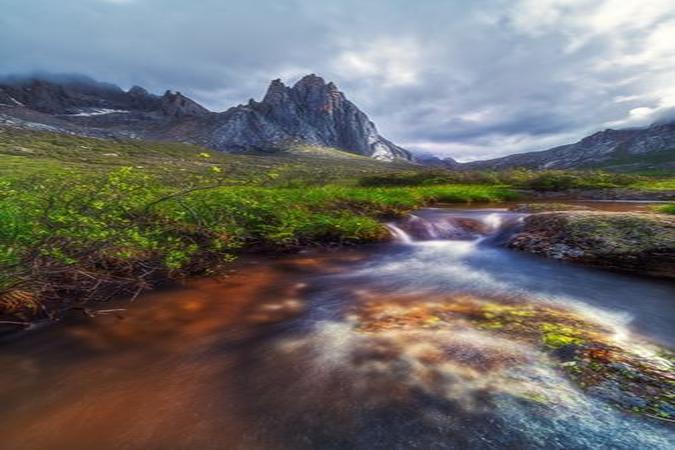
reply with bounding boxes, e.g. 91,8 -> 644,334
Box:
0,74 -> 412,161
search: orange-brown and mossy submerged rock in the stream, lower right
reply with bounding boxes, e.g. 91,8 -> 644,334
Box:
350,293 -> 675,420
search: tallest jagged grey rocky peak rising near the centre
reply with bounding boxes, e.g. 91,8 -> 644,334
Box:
202,74 -> 411,160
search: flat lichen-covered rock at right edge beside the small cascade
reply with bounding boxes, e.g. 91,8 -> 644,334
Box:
507,211 -> 675,278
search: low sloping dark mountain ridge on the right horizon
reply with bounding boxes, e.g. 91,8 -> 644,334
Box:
461,121 -> 675,171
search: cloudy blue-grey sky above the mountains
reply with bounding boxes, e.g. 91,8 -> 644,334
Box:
0,0 -> 675,161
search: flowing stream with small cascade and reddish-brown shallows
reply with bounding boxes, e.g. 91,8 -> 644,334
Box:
0,205 -> 675,450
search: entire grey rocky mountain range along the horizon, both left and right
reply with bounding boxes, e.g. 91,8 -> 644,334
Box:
0,74 -> 675,171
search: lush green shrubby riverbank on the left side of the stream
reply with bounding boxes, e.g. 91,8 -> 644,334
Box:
0,172 -> 515,326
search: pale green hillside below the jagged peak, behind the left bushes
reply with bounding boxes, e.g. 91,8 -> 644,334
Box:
0,128 -> 421,187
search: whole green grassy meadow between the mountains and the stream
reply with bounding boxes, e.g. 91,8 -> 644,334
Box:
0,128 -> 672,324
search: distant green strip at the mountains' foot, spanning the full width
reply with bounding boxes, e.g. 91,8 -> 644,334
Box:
0,128 -> 675,191
